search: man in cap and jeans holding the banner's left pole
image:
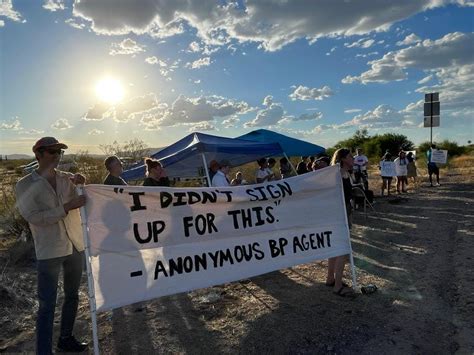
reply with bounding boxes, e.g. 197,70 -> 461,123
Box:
15,137 -> 87,354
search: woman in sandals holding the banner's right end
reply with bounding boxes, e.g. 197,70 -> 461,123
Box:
326,148 -> 356,298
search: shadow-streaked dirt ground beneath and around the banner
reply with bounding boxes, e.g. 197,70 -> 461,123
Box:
0,177 -> 474,354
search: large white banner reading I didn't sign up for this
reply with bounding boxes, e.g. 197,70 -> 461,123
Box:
85,166 -> 351,312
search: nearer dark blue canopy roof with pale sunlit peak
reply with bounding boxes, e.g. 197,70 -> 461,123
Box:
122,132 -> 283,180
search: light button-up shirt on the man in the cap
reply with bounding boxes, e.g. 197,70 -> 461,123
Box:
15,170 -> 84,260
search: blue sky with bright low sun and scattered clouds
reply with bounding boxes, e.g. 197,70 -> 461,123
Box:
0,0 -> 474,154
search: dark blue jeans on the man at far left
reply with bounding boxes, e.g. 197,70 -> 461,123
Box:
36,247 -> 84,355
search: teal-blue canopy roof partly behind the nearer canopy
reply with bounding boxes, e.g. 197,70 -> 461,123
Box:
237,129 -> 326,157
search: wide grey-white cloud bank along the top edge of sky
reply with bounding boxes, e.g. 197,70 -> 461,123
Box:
73,0 -> 469,51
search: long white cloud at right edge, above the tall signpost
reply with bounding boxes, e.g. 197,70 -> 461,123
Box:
342,32 -> 474,84
